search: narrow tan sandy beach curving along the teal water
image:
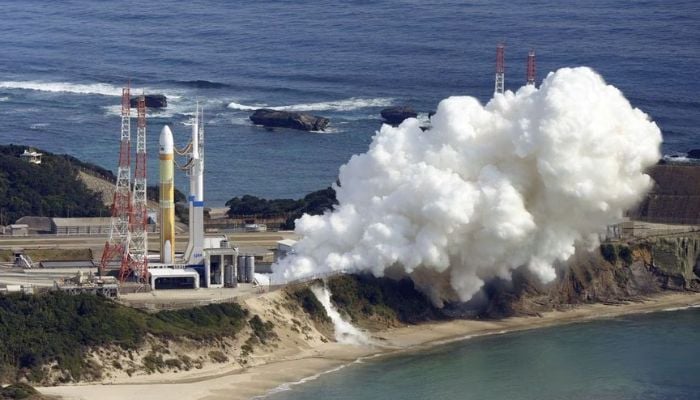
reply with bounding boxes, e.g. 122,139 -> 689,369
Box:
37,292 -> 700,400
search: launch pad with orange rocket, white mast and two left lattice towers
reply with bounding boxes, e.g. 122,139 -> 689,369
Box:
95,87 -> 243,290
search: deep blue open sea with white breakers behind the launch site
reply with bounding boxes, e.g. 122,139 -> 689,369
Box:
0,0 -> 700,205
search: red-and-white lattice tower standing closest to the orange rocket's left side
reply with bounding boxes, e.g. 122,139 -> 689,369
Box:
126,95 -> 148,282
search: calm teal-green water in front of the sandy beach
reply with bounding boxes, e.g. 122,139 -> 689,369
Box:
263,308 -> 700,400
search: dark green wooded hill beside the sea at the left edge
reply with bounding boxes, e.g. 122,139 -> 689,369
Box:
0,145 -> 109,225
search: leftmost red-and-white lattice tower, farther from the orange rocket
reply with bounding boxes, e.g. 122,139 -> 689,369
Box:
100,86 -> 131,276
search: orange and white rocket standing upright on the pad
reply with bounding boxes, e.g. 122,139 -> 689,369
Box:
160,125 -> 175,264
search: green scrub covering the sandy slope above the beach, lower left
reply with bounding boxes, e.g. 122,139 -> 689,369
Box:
0,292 -> 248,382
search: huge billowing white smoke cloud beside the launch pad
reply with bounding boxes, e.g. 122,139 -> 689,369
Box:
274,67 -> 661,302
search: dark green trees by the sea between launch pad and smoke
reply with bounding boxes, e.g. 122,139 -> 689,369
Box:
226,187 -> 338,229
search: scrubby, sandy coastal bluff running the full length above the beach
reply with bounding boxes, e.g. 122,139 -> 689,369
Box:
0,236 -> 700,385
